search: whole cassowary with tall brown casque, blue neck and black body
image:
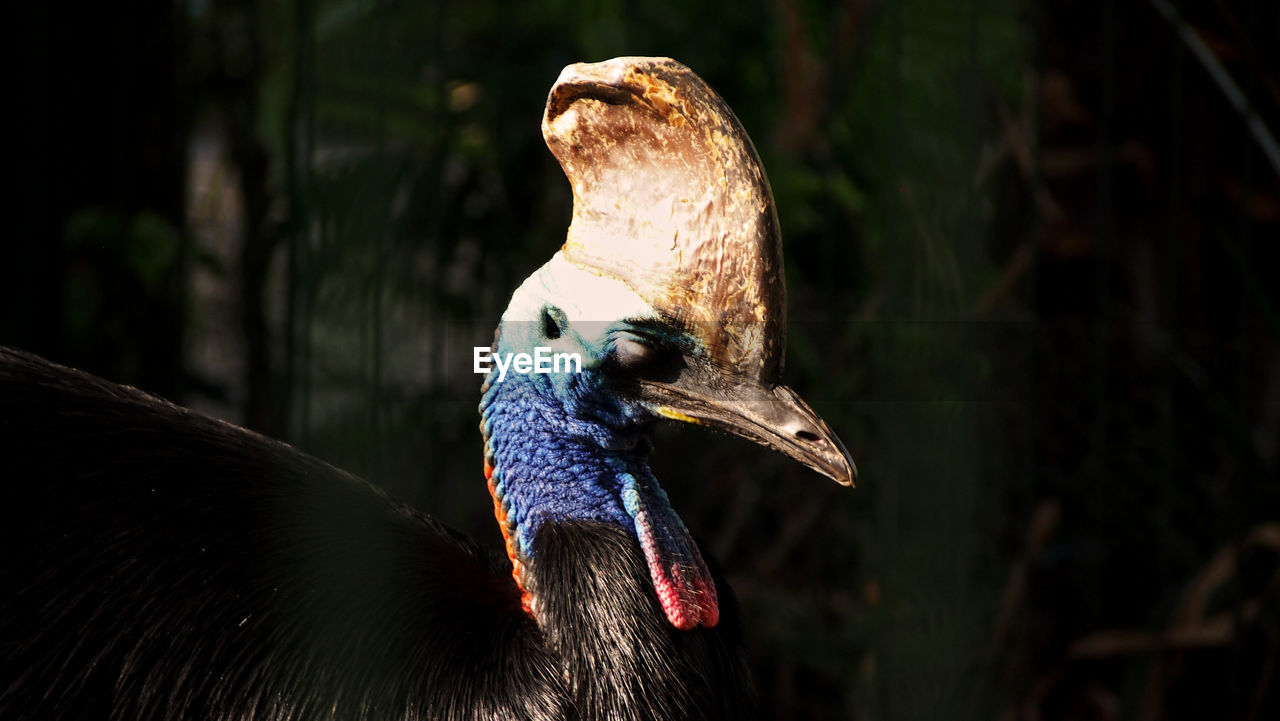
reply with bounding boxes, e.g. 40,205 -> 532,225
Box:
0,58 -> 854,721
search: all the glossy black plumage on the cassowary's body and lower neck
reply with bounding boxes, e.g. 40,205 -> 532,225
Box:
0,348 -> 751,721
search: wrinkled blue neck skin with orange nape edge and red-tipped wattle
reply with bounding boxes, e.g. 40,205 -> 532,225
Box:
480,361 -> 719,630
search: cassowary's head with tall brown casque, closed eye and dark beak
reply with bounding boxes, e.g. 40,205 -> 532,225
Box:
495,58 -> 856,485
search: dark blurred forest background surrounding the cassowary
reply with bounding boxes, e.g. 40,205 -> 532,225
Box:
0,0 -> 1280,721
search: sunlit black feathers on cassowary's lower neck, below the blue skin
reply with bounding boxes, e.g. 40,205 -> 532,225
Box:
536,523 -> 755,720
